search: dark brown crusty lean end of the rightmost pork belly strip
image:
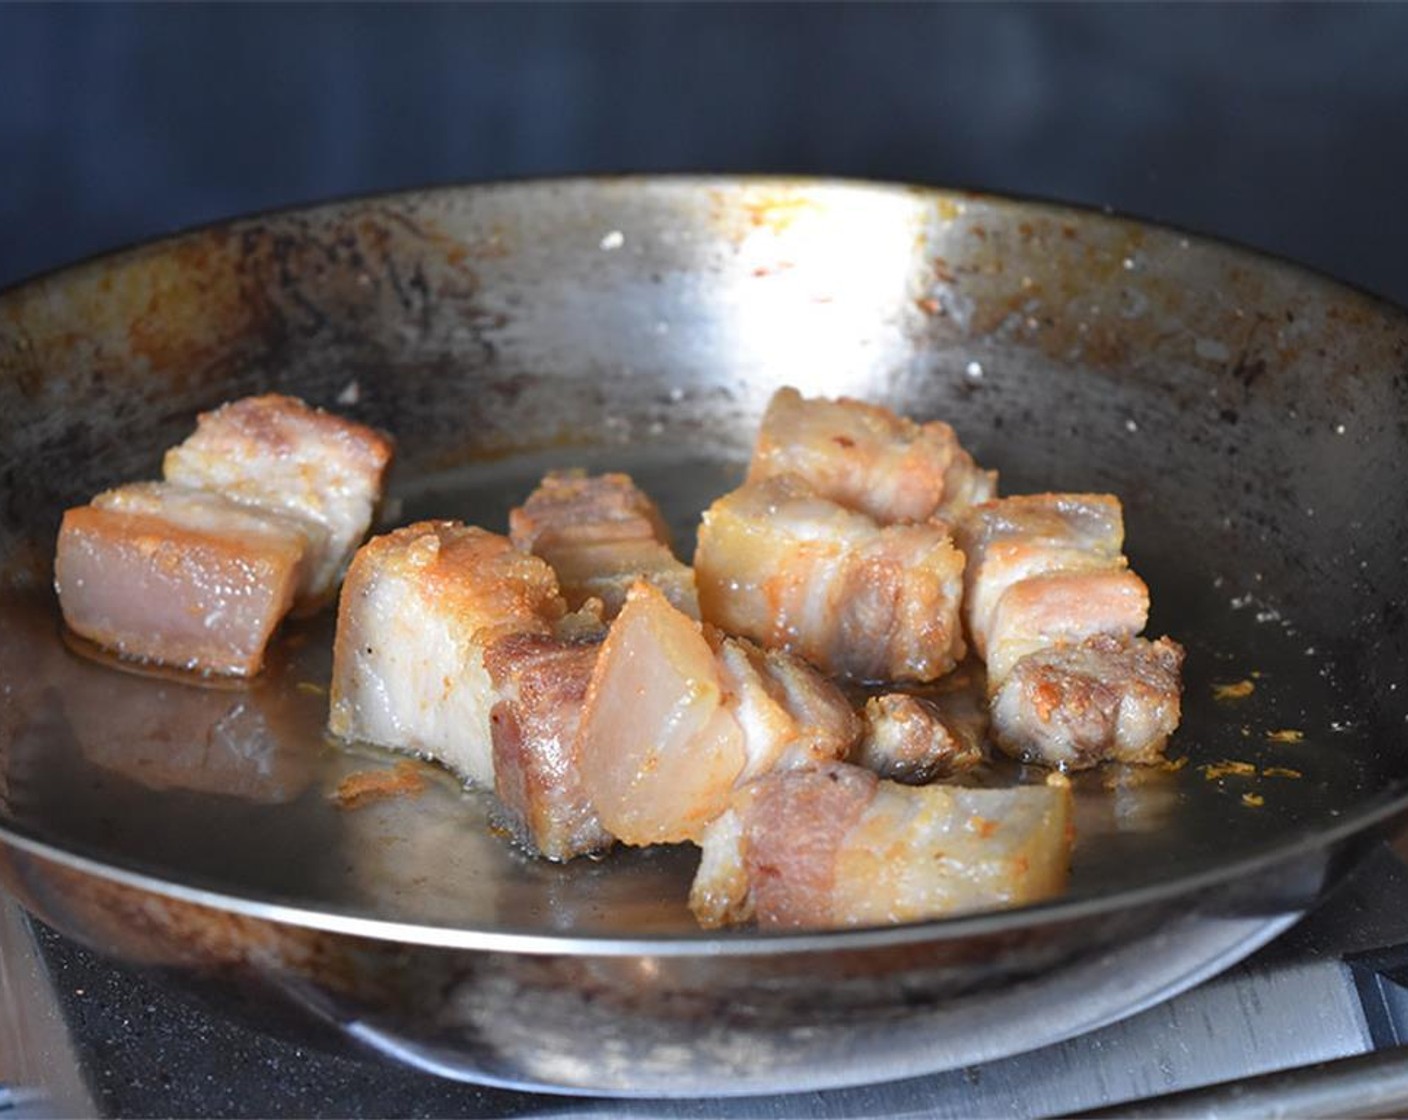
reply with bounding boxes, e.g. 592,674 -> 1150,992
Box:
993,634 -> 1183,769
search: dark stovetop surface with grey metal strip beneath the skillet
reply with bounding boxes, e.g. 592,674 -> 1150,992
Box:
11,845 -> 1408,1117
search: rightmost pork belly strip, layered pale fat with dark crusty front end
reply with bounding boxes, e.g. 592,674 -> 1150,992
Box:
957,494 -> 1183,768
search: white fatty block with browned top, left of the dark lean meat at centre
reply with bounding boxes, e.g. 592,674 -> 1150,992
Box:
328,521 -> 566,789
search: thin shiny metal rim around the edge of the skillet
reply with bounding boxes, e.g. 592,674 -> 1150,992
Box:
0,170 -> 1408,958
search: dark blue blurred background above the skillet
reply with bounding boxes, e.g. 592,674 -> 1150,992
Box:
0,4 -> 1408,303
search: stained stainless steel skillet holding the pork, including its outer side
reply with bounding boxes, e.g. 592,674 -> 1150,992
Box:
0,179 -> 1408,1096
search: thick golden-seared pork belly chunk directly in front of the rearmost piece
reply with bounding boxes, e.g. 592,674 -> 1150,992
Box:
694,475 -> 964,680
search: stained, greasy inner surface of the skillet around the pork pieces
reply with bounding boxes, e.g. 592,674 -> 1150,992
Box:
0,180 -> 1408,945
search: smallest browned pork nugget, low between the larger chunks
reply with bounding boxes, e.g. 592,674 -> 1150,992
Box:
850,692 -> 987,786
